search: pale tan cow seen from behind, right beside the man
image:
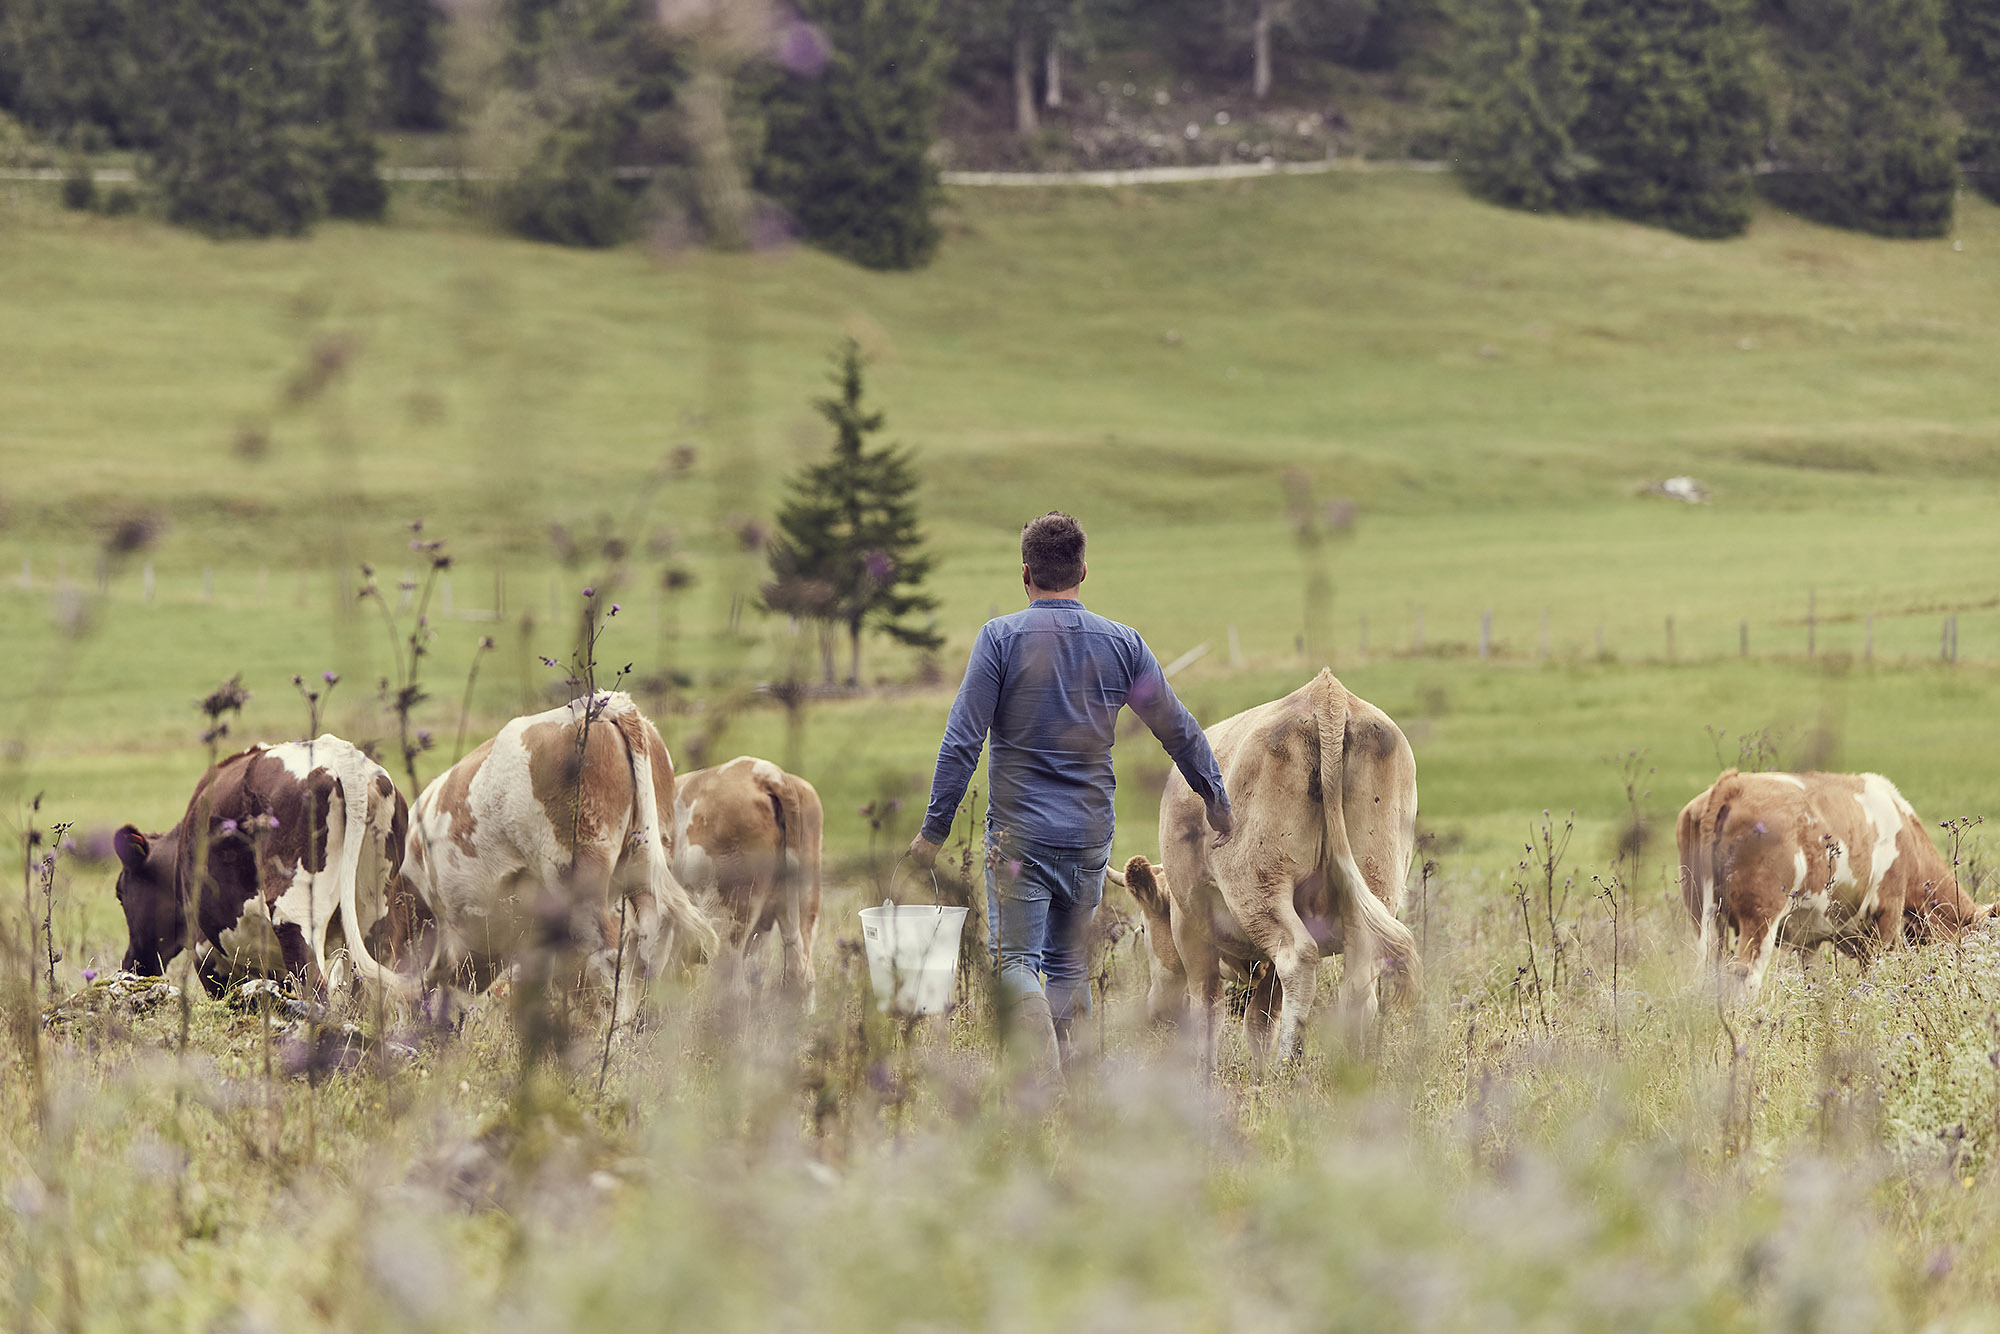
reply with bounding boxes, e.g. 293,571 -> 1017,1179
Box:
1124,670 -> 1420,1064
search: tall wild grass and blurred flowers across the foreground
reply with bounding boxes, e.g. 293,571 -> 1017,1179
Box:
11,828 -> 2000,1330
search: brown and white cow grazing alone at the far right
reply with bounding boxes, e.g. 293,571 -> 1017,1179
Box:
1674,770 -> 1994,1000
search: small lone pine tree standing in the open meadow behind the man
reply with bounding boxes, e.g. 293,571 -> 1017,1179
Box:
762,338 -> 944,686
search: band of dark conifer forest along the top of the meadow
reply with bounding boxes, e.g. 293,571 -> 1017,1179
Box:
0,0 -> 2000,258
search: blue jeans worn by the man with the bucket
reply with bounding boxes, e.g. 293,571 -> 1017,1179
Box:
986,834 -> 1112,1022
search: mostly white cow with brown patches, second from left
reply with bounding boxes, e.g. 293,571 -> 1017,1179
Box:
404,692 -> 716,1022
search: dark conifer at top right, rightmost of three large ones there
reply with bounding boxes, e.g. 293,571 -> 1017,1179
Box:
1766,0 -> 1958,236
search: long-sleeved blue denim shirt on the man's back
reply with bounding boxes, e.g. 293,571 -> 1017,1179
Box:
924,598 -> 1230,848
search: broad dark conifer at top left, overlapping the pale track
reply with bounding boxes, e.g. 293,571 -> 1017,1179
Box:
150,0 -> 326,236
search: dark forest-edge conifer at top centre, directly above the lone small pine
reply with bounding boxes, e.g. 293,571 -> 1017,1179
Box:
758,0 -> 948,268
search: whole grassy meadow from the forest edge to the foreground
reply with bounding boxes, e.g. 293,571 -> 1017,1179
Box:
0,172 -> 2000,1330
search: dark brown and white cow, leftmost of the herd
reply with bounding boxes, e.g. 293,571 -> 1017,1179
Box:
112,734 -> 414,996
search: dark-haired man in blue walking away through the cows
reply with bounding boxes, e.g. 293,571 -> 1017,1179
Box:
910,512 -> 1234,1082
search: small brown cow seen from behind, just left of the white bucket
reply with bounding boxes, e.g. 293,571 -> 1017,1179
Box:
674,756 -> 822,1010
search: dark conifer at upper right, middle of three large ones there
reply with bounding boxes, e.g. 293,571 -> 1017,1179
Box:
1574,0 -> 1766,236
